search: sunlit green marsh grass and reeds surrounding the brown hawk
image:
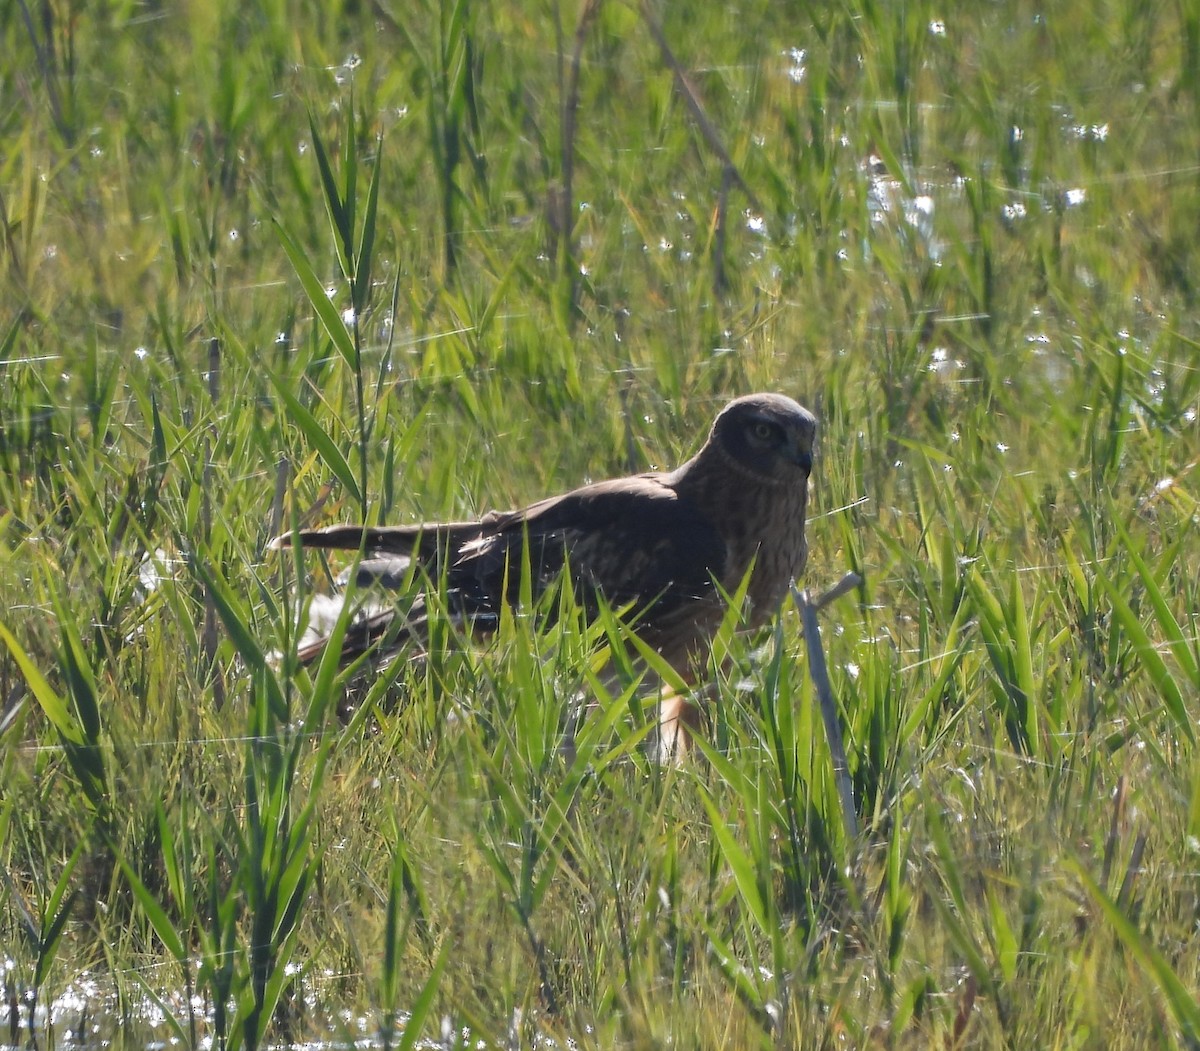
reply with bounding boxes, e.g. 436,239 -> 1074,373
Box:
0,0 -> 1200,1047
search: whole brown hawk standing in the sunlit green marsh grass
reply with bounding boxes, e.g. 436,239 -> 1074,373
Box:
271,394 -> 817,756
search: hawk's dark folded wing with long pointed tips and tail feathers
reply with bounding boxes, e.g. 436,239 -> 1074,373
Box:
272,475 -> 727,661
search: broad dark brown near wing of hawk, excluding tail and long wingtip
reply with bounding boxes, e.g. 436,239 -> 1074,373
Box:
446,475 -> 726,617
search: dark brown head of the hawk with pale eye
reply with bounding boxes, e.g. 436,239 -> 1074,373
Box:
708,394 -> 817,485
